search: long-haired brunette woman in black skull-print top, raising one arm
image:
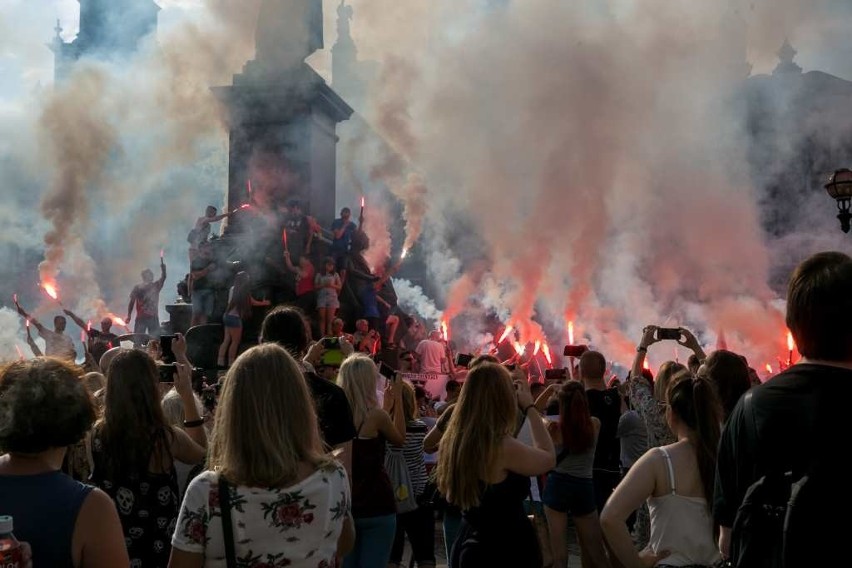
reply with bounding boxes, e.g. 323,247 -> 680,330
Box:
92,336 -> 207,568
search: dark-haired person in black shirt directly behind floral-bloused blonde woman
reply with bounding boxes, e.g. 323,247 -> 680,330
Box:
260,306 -> 356,474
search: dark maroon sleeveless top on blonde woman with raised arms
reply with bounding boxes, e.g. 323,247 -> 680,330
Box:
352,422 -> 396,519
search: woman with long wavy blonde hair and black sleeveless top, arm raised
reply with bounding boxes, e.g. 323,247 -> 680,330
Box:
437,363 -> 556,568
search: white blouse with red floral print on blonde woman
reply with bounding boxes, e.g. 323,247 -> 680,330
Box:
172,462 -> 351,568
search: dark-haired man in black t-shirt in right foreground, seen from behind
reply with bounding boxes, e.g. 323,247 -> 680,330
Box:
713,253 -> 852,566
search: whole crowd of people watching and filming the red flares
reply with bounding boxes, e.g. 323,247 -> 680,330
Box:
0,241 -> 852,568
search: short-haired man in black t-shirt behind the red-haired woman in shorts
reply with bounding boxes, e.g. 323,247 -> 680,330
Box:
580,351 -> 621,512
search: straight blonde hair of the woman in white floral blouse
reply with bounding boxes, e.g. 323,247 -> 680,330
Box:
209,343 -> 331,487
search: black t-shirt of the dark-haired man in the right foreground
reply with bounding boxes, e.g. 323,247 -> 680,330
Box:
713,364 -> 852,527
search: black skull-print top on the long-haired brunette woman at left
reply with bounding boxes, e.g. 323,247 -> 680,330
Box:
92,430 -> 180,568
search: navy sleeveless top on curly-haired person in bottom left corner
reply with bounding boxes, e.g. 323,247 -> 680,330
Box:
0,471 -> 94,568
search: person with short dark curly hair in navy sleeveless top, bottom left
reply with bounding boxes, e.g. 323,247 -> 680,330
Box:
0,359 -> 130,568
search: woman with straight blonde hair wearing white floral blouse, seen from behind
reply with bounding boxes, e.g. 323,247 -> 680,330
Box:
169,344 -> 352,568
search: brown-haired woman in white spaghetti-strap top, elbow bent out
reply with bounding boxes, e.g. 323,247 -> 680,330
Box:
601,374 -> 722,566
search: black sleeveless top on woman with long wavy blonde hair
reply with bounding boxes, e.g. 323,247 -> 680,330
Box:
449,472 -> 542,568
